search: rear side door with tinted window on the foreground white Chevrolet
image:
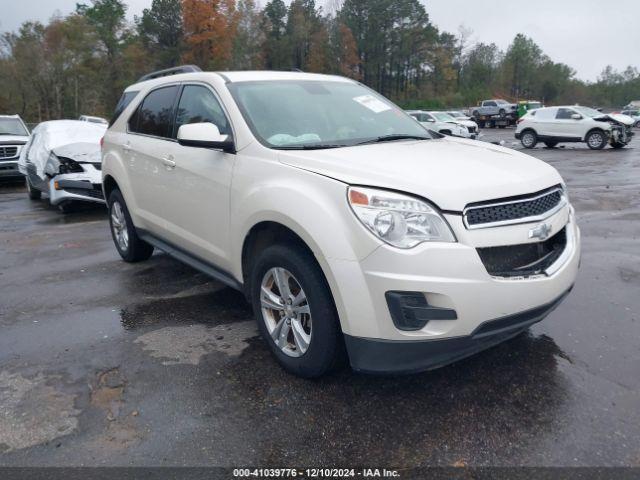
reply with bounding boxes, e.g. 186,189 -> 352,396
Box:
124,84 -> 180,234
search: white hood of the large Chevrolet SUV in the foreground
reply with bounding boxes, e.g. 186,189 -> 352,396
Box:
279,137 -> 562,211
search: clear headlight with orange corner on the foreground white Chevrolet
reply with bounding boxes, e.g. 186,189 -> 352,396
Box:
348,187 -> 456,248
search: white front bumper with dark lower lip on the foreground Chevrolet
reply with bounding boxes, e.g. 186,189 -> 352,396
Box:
332,204 -> 580,372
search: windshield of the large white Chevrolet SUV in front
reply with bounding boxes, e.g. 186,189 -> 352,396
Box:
229,80 -> 429,149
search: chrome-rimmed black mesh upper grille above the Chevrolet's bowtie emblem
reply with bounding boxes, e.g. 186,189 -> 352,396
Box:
464,187 -> 566,229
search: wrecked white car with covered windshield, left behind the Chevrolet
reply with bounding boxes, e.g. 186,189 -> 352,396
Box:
18,120 -> 107,212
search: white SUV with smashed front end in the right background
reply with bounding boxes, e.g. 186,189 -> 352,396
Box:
515,106 -> 634,150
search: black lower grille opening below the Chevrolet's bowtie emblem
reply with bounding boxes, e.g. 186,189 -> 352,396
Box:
477,228 -> 567,277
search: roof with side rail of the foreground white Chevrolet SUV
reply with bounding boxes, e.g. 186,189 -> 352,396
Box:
125,70 -> 355,91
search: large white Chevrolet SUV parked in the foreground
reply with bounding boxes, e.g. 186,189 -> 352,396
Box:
102,67 -> 580,377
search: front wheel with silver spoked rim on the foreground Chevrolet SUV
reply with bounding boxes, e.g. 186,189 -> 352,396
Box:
250,243 -> 345,378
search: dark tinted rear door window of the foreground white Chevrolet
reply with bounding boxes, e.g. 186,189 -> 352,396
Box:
129,85 -> 178,138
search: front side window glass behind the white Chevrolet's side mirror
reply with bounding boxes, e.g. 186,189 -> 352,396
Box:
174,85 -> 231,136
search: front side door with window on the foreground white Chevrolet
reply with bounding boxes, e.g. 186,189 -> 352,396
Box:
159,83 -> 236,270
